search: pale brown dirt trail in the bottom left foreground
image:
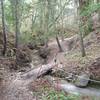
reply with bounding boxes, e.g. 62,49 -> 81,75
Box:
0,72 -> 35,100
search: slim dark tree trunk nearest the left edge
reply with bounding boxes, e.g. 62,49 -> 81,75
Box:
1,0 -> 7,55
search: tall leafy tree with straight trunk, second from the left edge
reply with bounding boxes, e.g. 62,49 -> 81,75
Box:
7,0 -> 23,48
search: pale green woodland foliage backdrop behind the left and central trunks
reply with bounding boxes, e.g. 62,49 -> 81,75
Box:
2,0 -> 74,43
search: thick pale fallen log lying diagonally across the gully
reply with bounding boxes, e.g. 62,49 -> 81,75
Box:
21,62 -> 56,79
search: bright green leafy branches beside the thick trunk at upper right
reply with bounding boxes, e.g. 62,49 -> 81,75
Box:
80,2 -> 100,36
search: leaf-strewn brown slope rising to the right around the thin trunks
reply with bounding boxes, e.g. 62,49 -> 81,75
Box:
49,31 -> 100,83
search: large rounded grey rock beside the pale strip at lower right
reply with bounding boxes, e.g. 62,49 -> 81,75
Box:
75,74 -> 90,87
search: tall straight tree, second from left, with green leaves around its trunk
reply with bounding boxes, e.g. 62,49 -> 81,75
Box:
9,0 -> 24,48
